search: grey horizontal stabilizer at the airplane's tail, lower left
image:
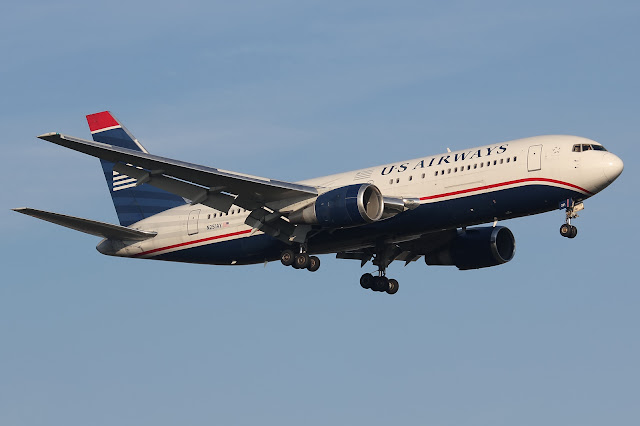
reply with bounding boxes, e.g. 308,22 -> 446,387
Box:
13,207 -> 156,241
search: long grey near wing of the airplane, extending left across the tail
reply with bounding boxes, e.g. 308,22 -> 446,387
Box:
38,133 -> 318,211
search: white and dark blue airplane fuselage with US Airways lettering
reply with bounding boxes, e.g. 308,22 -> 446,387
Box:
98,136 -> 622,264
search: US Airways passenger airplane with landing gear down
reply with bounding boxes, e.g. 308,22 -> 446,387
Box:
13,111 -> 624,294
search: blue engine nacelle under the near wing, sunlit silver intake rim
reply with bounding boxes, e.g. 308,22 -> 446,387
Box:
289,183 -> 384,228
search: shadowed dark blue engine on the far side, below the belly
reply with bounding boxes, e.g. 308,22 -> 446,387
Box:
424,226 -> 516,270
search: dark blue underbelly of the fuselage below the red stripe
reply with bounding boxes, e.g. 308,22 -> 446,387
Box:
152,185 -> 584,265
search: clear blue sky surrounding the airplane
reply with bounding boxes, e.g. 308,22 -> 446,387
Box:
0,0 -> 640,426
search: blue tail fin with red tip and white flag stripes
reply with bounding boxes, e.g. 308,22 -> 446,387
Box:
87,111 -> 185,226
